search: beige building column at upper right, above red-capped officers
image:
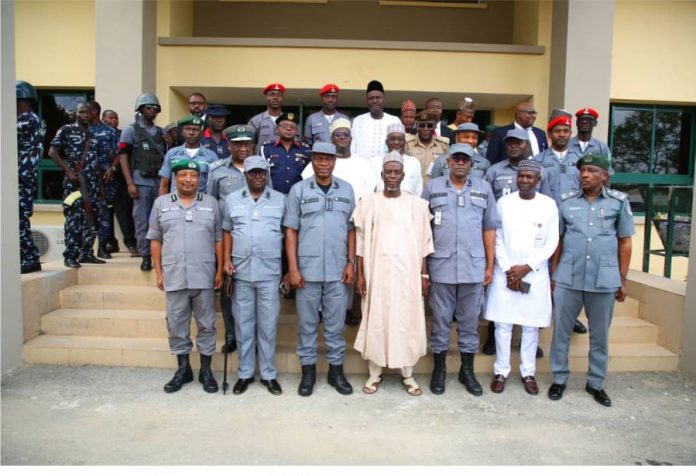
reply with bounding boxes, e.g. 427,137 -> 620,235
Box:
549,0 -> 614,142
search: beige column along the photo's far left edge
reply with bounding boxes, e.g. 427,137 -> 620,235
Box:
0,0 -> 24,374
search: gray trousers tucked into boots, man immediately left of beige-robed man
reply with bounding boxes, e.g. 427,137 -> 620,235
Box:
295,281 -> 346,365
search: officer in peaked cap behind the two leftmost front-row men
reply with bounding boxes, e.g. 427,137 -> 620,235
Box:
208,124 -> 254,352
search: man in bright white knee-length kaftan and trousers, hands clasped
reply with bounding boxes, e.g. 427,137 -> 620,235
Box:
486,160 -> 559,395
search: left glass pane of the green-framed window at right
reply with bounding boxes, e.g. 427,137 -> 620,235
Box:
612,107 -> 653,173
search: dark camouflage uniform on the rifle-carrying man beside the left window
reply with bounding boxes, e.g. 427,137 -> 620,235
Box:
51,122 -> 107,261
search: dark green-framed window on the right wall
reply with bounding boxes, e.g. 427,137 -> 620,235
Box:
609,104 -> 696,214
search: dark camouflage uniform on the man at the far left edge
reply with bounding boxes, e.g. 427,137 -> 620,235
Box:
17,111 -> 46,266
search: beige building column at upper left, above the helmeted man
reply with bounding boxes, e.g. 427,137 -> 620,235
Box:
94,0 -> 157,122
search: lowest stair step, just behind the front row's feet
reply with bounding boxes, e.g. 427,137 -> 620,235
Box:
24,335 -> 678,374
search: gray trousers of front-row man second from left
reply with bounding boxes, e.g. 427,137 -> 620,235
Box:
232,279 -> 280,380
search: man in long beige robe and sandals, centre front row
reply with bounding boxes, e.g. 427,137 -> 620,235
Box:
352,152 -> 433,396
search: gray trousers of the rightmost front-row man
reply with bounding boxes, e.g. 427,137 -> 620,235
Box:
550,285 -> 616,389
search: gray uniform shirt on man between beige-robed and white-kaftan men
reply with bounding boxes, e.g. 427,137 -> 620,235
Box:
423,177 -> 499,284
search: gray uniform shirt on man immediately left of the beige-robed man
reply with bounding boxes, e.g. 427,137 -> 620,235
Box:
283,177 -> 355,282
